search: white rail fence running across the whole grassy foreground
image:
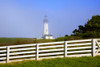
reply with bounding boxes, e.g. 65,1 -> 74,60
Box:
0,39 -> 100,63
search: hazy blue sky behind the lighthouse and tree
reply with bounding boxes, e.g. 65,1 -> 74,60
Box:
0,0 -> 100,38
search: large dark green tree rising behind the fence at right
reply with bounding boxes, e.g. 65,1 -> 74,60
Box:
72,15 -> 100,38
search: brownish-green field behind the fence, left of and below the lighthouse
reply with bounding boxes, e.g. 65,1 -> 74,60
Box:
0,38 -> 53,46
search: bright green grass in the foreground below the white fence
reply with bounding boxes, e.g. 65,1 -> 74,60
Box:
0,56 -> 100,67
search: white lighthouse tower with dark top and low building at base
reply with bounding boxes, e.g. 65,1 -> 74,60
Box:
42,16 -> 53,39
